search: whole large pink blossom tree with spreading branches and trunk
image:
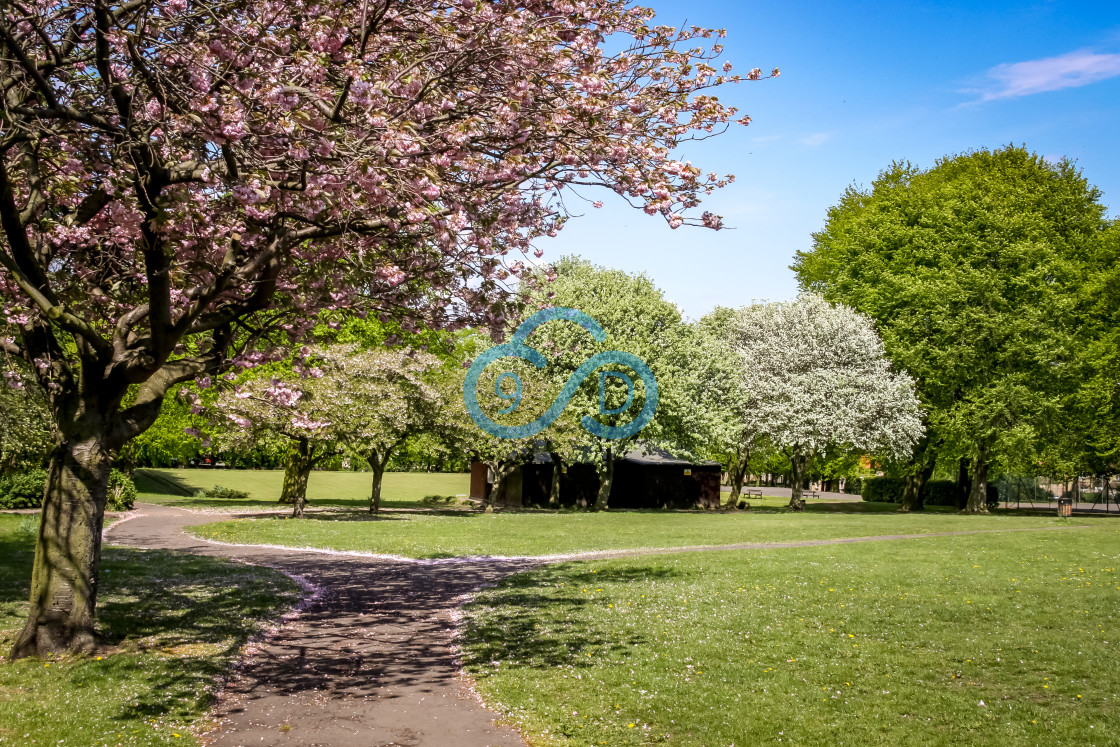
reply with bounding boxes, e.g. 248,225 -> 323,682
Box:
0,0 -> 762,657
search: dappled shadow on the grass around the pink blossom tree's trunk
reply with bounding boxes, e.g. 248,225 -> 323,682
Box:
0,526 -> 297,721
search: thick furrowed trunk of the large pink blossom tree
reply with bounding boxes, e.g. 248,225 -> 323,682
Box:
11,433 -> 112,660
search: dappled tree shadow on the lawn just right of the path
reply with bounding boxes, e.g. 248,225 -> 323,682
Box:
463,563 -> 682,674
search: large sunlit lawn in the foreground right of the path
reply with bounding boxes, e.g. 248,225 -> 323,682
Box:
464,524 -> 1120,747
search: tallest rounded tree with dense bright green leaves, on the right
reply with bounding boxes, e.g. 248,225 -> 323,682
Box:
793,146 -> 1107,513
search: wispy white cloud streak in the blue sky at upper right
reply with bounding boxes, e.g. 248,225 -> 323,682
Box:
979,50 -> 1120,101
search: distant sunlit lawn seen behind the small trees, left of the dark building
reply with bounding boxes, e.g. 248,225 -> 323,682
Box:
136,469 -> 470,511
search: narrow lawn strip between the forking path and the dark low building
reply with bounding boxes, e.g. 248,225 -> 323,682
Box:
189,503 -> 1080,558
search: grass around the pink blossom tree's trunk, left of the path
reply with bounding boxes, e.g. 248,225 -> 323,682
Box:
0,515 -> 297,746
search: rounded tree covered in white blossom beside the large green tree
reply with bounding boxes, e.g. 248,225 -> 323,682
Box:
731,295 -> 923,511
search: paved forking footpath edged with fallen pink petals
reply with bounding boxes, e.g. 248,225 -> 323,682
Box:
105,504 -> 1080,747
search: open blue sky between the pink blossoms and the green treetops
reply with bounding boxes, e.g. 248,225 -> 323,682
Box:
539,0 -> 1120,318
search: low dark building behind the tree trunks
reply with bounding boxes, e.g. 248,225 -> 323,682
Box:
470,447 -> 720,508
